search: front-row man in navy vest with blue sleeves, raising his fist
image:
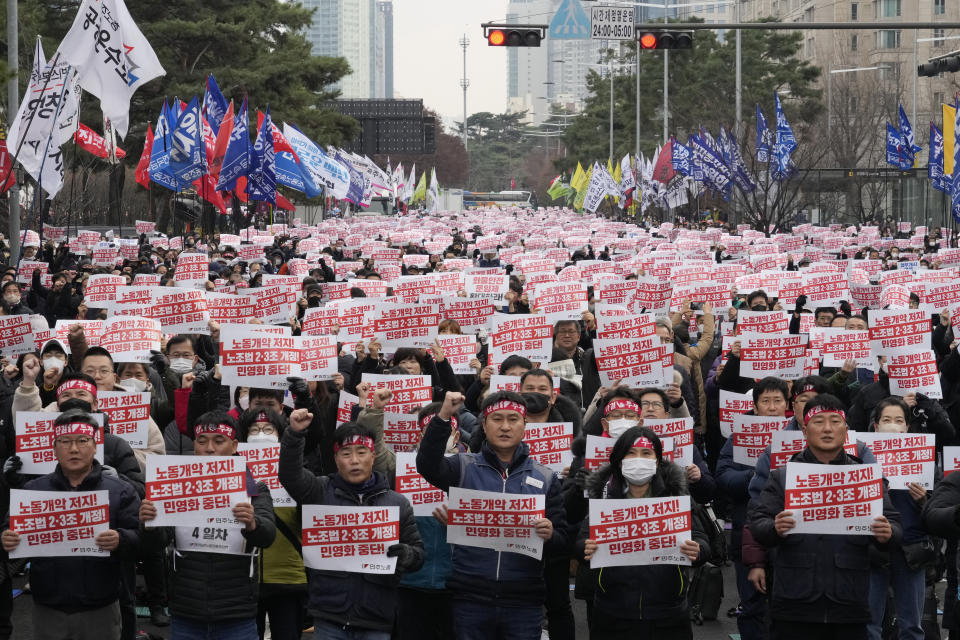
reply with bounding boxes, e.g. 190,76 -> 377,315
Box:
417,391 -> 567,640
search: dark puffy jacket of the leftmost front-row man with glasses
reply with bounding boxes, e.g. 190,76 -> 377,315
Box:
24,460 -> 140,613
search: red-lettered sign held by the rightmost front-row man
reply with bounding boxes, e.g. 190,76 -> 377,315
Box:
783,462 -> 883,535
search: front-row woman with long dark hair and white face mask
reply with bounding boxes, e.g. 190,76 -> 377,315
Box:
577,427 -> 710,640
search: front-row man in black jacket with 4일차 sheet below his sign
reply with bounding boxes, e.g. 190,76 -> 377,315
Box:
140,411 -> 277,640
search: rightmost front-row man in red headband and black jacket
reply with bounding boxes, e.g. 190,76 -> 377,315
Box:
749,394 -> 902,640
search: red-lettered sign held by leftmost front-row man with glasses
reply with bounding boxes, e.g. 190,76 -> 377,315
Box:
10,489 -> 110,558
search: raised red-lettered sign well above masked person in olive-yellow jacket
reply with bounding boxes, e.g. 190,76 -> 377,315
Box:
220,325 -> 301,389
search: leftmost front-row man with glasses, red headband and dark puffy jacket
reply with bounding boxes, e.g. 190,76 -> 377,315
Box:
0,409 -> 140,640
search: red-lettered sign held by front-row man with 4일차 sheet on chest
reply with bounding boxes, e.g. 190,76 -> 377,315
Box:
145,454 -> 250,528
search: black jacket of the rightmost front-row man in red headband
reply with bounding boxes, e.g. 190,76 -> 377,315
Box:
748,449 -> 903,624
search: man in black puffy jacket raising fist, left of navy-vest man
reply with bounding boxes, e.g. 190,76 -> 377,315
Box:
278,409 -> 423,640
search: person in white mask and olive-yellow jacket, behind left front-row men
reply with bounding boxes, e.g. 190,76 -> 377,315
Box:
237,409 -> 307,640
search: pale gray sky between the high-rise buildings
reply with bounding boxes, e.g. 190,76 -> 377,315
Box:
393,0 -> 507,127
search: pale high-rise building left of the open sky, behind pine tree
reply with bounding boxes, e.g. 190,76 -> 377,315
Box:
303,0 -> 393,98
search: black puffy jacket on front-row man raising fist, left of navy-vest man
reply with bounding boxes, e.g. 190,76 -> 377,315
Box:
278,429 -> 426,632
